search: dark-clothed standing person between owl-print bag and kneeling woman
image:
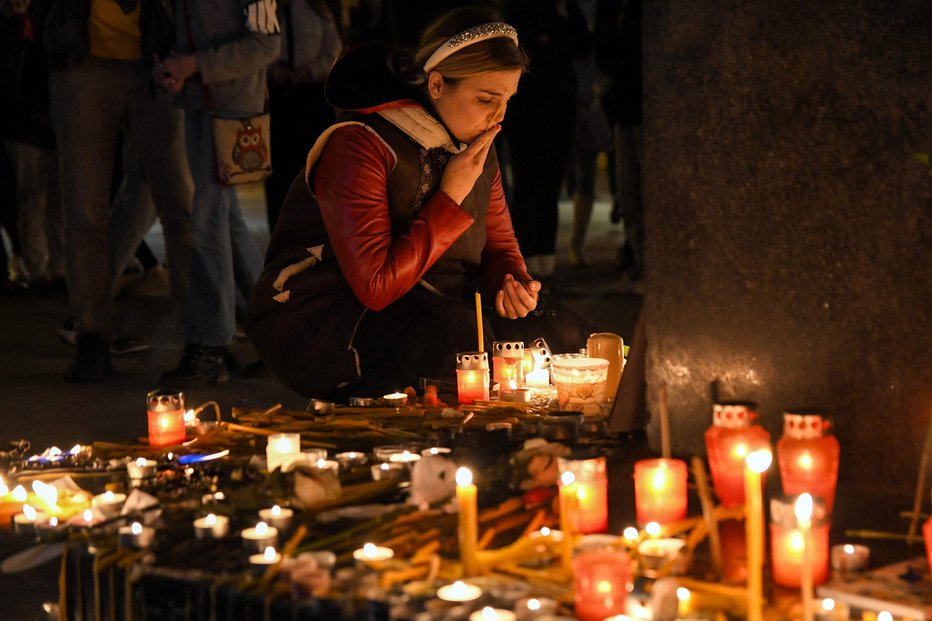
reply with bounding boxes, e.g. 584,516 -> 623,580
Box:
265,0 -> 343,232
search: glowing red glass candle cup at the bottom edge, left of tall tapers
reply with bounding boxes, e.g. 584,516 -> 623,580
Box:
573,548 -> 631,621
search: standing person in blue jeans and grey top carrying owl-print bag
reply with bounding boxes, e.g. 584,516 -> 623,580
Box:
154,0 -> 281,388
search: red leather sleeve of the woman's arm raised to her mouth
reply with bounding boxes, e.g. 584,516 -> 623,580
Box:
311,125 -> 474,311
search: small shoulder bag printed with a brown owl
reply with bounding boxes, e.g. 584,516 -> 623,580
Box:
211,113 -> 272,185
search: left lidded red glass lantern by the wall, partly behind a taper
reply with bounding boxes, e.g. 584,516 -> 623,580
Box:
705,402 -> 770,507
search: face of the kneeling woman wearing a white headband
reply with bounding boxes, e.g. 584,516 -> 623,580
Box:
427,69 -> 521,143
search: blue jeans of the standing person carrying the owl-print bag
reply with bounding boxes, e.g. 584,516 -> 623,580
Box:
184,110 -> 262,347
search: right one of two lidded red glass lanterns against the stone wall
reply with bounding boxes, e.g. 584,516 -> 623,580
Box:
777,410 -> 841,514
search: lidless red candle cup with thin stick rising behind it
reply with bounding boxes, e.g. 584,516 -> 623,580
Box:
634,459 -> 687,525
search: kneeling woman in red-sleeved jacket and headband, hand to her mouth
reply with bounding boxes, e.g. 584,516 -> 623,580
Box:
247,9 -> 586,400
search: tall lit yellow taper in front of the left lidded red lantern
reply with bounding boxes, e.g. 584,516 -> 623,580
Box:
744,449 -> 773,621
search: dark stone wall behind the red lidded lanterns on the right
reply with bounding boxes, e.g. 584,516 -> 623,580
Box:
643,0 -> 932,490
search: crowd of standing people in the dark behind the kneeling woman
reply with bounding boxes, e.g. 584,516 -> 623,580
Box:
0,0 -> 643,387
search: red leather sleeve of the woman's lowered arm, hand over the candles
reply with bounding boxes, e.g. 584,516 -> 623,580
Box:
479,172 -> 531,300
